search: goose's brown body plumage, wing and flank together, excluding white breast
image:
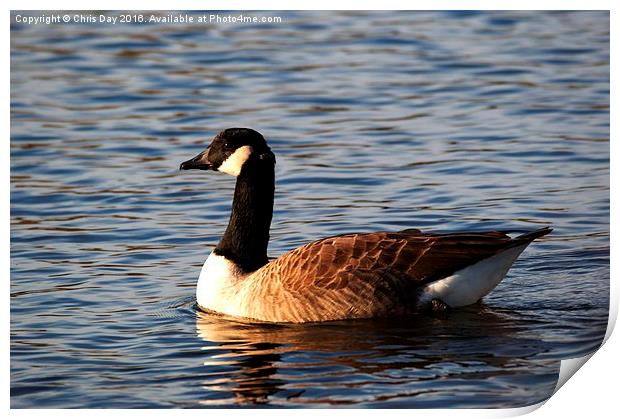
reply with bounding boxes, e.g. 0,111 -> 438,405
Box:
252,231 -> 528,321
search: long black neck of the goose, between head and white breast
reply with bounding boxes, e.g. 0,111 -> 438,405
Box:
215,159 -> 275,272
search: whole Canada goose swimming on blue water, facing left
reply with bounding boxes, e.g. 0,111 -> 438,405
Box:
180,128 -> 551,323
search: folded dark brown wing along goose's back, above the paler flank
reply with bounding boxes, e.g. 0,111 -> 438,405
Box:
275,232 -> 513,290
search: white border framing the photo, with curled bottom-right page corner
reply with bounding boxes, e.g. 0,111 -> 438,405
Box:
1,0 -> 619,419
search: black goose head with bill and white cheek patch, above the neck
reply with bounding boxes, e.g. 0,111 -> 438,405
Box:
179,128 -> 275,176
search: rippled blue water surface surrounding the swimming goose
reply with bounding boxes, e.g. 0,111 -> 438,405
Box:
11,12 -> 609,408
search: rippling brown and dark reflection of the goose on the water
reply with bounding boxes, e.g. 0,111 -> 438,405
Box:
196,304 -> 559,407
